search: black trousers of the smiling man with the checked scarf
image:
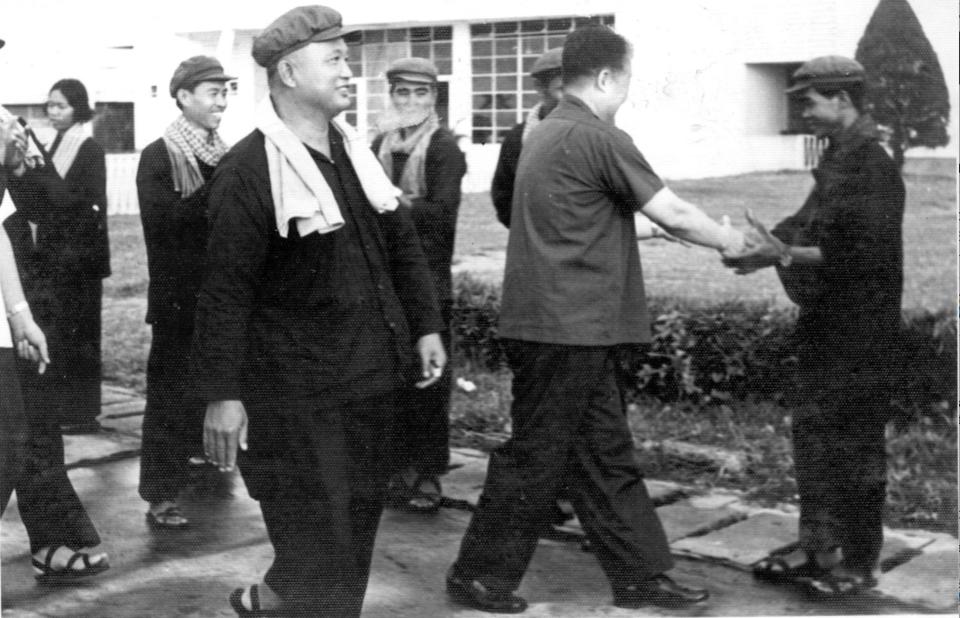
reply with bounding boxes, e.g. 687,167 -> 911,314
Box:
140,322 -> 205,503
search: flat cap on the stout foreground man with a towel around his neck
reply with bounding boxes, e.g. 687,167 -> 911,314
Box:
250,4 -> 354,67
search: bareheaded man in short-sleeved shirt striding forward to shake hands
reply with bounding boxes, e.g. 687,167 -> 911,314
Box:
447,26 -> 743,613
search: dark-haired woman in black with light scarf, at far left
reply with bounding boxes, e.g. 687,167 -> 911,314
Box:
8,79 -> 110,433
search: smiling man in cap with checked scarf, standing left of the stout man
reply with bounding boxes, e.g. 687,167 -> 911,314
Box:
137,56 -> 234,529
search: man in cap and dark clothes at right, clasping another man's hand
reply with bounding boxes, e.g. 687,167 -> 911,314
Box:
725,56 -> 904,596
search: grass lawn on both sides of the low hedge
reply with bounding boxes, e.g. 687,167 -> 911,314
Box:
97,172 -> 957,534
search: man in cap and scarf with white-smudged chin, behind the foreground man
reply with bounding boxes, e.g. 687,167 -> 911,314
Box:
373,58 -> 467,513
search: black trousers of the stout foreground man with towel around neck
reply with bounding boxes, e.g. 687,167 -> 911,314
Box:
240,394 -> 396,618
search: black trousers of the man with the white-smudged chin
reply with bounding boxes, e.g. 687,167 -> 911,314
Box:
393,301 -> 453,476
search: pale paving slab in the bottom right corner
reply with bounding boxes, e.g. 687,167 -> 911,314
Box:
876,539 -> 960,615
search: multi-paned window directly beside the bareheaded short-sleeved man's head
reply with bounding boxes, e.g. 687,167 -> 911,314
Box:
470,15 -> 613,144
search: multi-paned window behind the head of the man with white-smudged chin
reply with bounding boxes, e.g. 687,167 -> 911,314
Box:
346,26 -> 453,139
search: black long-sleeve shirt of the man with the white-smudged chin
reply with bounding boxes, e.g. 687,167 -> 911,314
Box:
372,128 -> 467,301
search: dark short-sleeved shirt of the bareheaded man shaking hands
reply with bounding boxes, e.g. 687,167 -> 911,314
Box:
500,95 -> 663,345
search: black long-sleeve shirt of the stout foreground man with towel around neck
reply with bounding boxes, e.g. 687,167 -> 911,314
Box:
194,127 -> 443,404
